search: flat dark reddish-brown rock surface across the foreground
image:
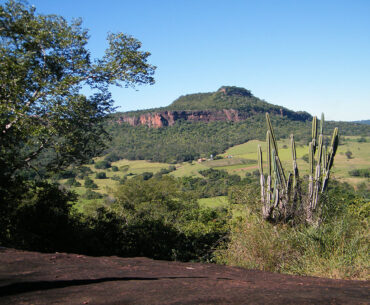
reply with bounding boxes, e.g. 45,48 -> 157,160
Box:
0,248 -> 370,304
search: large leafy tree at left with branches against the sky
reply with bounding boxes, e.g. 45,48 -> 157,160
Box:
0,0 -> 155,180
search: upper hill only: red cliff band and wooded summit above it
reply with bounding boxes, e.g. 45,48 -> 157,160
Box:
116,86 -> 312,128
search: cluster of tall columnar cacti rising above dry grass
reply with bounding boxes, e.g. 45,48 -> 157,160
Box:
257,113 -> 338,223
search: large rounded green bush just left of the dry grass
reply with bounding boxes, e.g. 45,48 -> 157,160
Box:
113,176 -> 226,260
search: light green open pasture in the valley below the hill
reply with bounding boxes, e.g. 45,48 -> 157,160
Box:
60,137 -> 370,202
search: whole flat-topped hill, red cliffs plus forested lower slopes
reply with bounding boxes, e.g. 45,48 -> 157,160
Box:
106,86 -> 370,163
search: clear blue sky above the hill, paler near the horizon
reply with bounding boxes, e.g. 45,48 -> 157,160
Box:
29,0 -> 370,121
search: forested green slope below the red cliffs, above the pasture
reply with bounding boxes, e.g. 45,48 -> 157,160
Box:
106,113 -> 370,163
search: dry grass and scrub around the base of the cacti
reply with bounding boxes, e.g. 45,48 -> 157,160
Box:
215,182 -> 370,279
